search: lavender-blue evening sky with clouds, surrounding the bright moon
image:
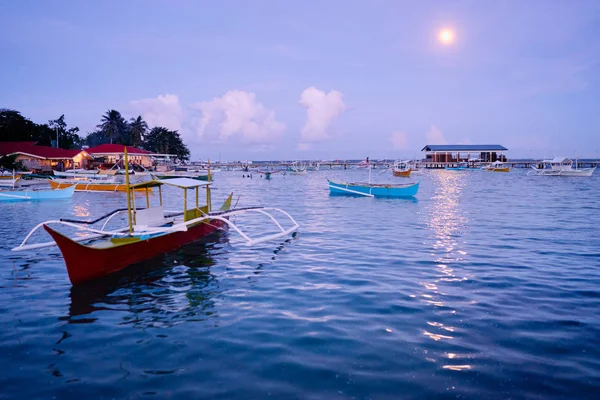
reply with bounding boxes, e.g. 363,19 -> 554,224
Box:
0,0 -> 600,161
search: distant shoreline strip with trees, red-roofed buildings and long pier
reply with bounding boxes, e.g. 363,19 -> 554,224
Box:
0,109 -> 598,176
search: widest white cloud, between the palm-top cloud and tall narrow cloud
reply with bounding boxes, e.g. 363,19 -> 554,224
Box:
191,90 -> 286,144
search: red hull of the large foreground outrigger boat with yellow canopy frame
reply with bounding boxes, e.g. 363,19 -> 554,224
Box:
44,220 -> 225,285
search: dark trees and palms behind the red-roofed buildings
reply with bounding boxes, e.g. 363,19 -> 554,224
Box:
0,108 -> 190,160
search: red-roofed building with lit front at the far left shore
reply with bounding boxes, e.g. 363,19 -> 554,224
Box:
0,142 -> 92,171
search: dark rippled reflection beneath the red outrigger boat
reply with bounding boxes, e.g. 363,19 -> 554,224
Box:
59,234 -> 227,327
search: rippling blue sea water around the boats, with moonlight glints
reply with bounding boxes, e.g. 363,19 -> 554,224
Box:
0,170 -> 600,399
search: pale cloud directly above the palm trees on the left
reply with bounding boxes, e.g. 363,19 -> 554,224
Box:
129,94 -> 183,131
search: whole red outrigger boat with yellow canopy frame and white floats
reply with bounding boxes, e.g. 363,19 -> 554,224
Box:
12,149 -> 299,285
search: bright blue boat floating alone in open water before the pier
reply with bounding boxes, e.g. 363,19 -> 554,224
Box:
327,178 -> 419,197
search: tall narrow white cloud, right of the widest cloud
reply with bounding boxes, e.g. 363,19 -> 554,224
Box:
299,87 -> 346,148
